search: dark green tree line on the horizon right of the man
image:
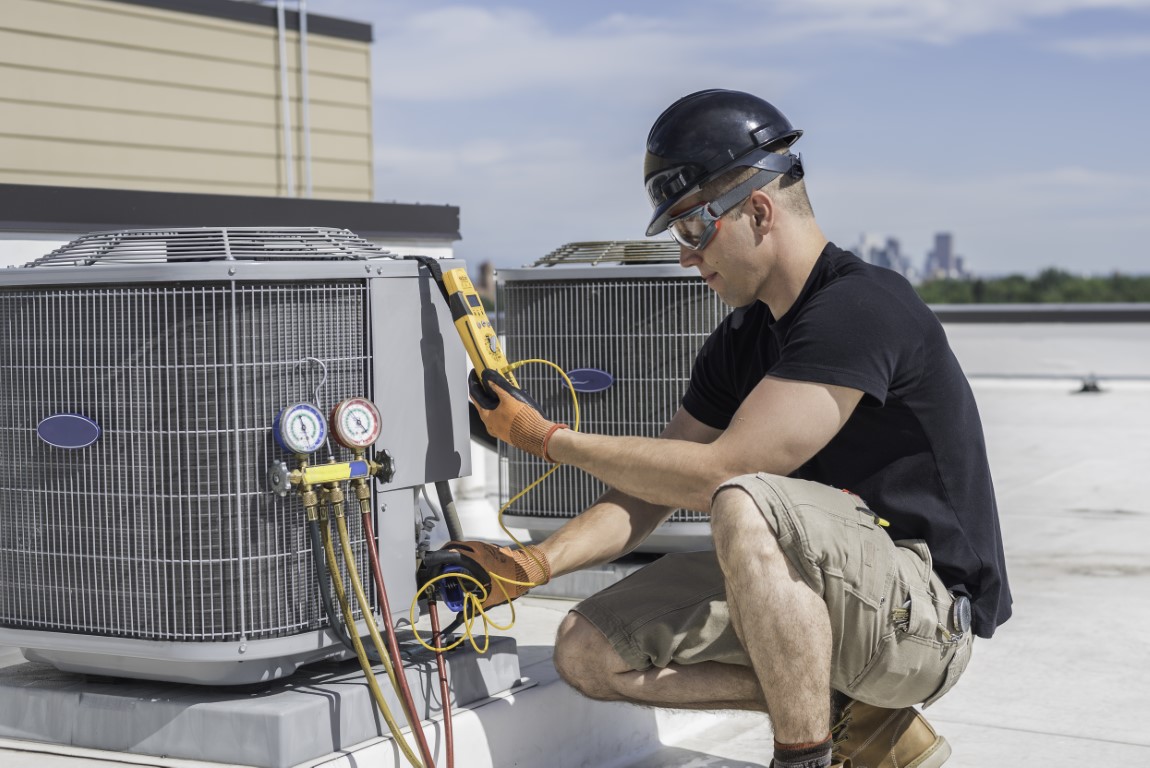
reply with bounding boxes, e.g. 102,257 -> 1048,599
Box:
917,268 -> 1150,304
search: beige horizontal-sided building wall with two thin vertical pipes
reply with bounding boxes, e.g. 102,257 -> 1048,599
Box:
0,0 -> 373,200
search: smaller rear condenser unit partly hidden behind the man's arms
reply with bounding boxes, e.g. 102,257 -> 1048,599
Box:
496,240 -> 728,552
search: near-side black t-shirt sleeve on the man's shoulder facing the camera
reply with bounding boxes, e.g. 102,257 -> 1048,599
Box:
767,279 -> 918,405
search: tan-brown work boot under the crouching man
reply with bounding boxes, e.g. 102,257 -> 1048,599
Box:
833,701 -> 950,768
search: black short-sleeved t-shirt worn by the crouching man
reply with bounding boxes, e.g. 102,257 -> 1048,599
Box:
683,244 -> 1011,637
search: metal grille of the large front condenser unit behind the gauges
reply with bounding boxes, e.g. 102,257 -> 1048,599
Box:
0,282 -> 369,642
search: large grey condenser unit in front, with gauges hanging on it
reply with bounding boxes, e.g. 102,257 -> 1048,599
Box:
0,228 -> 470,684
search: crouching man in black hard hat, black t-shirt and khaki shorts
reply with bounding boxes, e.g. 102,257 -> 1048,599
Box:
449,90 -> 1011,768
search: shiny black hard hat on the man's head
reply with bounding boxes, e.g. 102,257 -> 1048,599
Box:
643,89 -> 803,237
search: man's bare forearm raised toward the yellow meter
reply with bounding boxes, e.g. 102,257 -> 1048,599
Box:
547,430 -> 726,510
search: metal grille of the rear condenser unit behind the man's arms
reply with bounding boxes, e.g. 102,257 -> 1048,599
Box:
498,274 -> 728,523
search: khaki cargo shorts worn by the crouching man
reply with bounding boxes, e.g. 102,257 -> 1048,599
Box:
575,474 -> 973,707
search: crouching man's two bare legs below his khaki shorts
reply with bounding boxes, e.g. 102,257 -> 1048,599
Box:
555,489 -> 831,744
